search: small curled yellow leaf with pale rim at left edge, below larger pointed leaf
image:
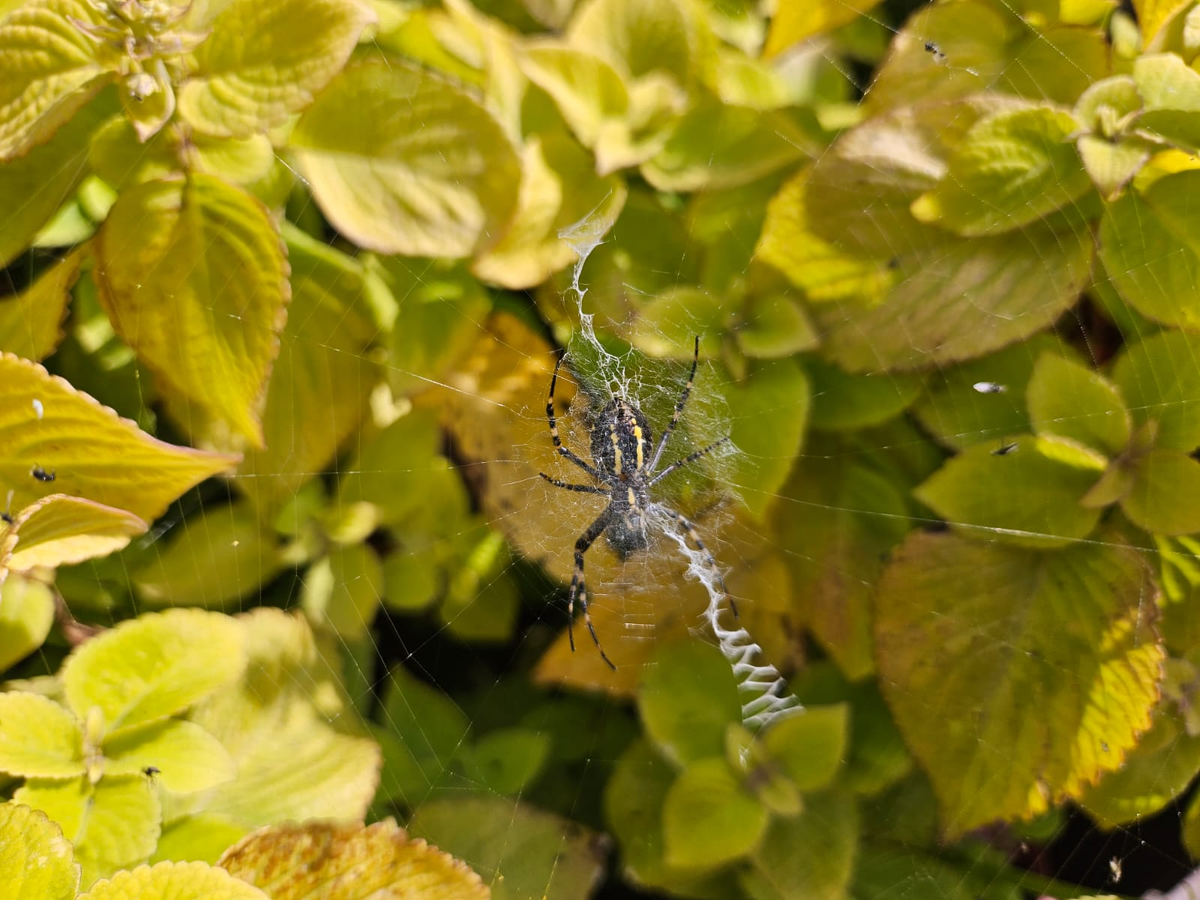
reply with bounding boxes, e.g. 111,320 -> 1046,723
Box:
6,493 -> 150,571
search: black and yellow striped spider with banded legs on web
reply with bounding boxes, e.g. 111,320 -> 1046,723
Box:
538,336 -> 738,671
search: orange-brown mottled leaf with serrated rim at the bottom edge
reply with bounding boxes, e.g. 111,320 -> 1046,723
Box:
218,818 -> 491,900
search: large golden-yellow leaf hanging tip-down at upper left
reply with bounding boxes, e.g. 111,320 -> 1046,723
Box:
96,174 -> 289,445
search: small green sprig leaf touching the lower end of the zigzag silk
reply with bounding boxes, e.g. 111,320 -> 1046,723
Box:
762,703 -> 850,792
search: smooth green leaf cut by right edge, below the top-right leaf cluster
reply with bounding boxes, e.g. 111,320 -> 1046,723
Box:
1100,170 -> 1200,328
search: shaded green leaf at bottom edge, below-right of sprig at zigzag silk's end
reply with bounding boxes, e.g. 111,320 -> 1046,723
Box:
739,793 -> 859,900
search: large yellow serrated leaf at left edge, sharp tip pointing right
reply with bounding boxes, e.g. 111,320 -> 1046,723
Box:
0,354 -> 235,522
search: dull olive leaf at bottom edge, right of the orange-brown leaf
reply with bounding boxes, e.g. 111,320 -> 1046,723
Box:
408,794 -> 604,900
